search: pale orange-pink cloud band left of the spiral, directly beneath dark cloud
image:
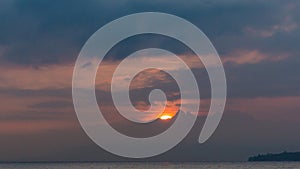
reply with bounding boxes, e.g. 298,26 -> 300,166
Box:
0,65 -> 73,90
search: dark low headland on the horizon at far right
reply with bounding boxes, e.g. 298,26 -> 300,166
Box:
248,152 -> 300,161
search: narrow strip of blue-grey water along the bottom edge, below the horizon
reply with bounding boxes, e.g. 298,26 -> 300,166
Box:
0,162 -> 300,169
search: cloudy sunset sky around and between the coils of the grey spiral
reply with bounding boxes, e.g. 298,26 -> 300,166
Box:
0,0 -> 300,161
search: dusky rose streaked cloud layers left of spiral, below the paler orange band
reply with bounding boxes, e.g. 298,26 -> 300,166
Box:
0,86 -> 76,135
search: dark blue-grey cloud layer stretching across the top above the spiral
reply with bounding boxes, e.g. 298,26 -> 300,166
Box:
0,0 -> 299,65
